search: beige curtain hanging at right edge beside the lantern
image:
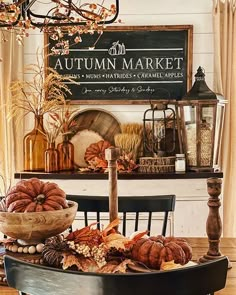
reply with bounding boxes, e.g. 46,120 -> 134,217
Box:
213,0 -> 236,237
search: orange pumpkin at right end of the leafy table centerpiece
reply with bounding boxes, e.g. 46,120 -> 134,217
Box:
131,235 -> 192,269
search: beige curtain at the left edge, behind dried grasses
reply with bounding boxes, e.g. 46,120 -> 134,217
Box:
0,31 -> 23,194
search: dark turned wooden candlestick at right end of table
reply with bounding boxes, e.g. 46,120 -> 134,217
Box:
199,177 -> 230,268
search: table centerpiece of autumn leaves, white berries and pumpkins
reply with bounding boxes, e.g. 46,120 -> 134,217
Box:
37,219 -> 192,273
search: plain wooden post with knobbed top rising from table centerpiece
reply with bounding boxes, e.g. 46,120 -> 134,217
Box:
105,147 -> 120,230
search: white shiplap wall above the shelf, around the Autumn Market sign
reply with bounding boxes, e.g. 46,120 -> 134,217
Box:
24,0 -> 213,131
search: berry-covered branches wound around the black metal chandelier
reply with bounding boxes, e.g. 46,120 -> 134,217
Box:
0,0 -> 119,54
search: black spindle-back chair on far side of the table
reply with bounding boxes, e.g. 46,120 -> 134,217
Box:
67,195 -> 176,236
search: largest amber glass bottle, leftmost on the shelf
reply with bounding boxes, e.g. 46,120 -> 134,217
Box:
24,116 -> 47,171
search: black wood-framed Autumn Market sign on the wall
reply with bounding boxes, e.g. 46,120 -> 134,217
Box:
45,25 -> 193,104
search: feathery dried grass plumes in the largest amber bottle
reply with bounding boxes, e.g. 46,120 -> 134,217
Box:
10,50 -> 78,118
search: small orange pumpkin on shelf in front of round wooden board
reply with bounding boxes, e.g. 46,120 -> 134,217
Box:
84,140 -> 111,162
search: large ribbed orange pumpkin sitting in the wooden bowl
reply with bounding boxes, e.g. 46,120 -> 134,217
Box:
5,178 -> 68,212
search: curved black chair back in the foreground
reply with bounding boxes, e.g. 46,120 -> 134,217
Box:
4,255 -> 228,295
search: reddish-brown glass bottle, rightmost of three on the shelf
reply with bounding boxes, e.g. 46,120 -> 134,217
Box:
57,134 -> 74,171
